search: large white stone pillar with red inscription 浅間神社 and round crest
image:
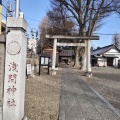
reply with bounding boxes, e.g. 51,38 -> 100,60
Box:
3,17 -> 27,120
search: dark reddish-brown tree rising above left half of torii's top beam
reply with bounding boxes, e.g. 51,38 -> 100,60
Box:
47,3 -> 74,35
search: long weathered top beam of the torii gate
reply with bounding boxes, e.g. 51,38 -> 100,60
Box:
46,35 -> 99,40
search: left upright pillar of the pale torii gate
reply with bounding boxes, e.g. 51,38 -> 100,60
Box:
52,39 -> 57,75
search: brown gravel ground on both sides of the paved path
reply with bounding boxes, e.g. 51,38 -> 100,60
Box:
25,65 -> 120,120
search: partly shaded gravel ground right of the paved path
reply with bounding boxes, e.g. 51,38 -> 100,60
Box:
73,67 -> 120,112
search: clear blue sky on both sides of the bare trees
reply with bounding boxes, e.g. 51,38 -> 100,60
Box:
2,0 -> 120,48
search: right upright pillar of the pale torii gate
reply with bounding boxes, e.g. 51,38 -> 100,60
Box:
86,40 -> 92,77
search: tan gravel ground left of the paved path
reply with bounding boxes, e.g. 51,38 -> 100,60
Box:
25,69 -> 62,120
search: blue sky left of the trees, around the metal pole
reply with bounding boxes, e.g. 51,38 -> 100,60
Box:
2,0 -> 50,34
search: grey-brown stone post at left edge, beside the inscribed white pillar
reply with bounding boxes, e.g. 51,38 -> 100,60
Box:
0,35 -> 5,120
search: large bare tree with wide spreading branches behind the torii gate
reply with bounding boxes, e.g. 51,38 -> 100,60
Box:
51,0 -> 120,69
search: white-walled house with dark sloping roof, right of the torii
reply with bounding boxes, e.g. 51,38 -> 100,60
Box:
91,44 -> 120,67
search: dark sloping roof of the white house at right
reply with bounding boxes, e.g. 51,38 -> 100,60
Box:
91,44 -> 120,55
